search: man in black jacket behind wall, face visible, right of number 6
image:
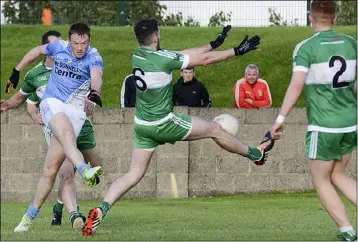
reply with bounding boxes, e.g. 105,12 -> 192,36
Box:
173,68 -> 211,107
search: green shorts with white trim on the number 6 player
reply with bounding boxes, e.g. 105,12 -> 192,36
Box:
133,113 -> 191,150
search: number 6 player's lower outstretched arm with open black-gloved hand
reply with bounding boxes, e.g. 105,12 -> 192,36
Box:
188,35 -> 260,68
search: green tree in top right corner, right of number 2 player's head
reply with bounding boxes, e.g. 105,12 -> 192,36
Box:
337,1 -> 357,25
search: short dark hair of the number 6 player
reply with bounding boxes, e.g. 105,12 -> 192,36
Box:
134,18 -> 159,44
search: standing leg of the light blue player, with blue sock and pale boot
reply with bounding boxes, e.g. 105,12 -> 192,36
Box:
14,137 -> 65,232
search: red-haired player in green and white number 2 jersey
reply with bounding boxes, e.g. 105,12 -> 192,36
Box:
271,0 -> 357,241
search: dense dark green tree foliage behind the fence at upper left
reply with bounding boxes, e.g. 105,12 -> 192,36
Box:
3,0 -> 167,25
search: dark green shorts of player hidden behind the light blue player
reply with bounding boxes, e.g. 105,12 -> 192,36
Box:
42,119 -> 96,150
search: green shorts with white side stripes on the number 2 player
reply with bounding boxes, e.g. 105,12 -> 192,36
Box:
306,131 -> 357,161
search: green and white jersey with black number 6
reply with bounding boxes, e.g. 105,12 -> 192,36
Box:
132,47 -> 189,125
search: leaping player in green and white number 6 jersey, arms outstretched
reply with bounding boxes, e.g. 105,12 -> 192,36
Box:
83,19 -> 273,236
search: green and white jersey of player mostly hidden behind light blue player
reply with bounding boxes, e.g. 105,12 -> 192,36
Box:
20,62 -> 52,104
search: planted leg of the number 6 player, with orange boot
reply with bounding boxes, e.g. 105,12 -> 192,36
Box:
82,148 -> 154,236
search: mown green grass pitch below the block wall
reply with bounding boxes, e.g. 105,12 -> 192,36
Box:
1,192 -> 357,241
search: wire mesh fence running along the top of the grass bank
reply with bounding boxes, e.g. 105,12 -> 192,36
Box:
1,0 -> 357,27
